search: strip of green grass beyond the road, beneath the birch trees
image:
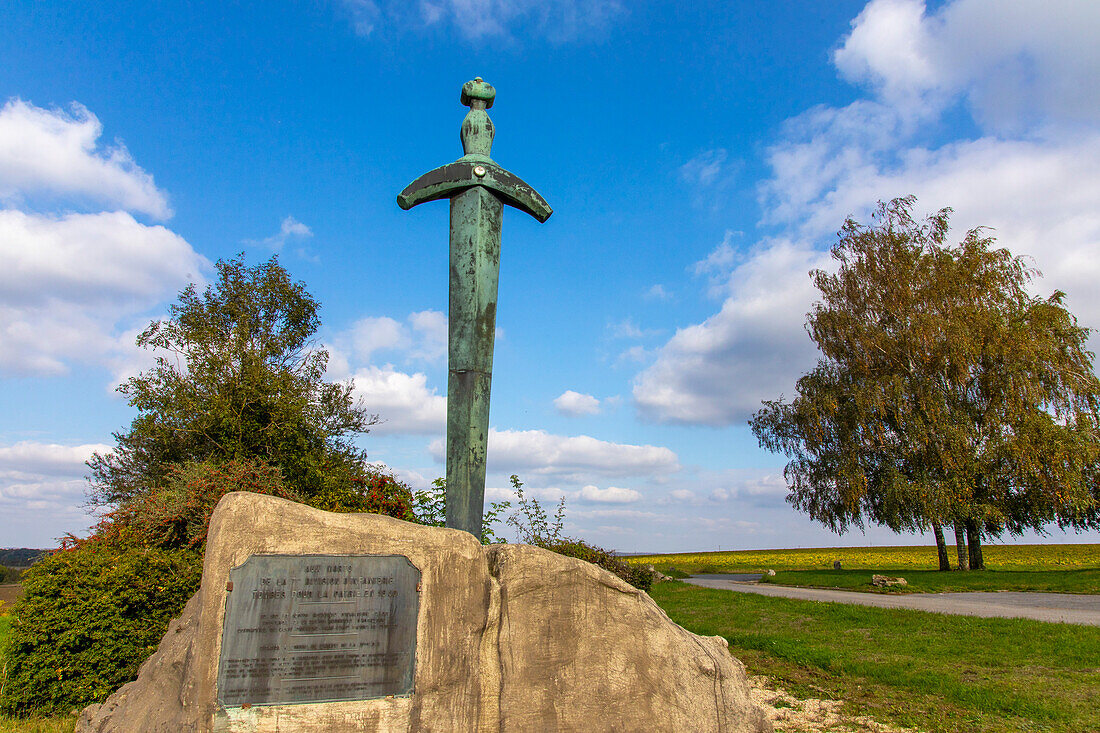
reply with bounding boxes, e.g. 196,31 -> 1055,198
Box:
761,570 -> 1100,593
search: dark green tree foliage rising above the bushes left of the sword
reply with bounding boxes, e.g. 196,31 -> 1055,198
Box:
89,256 -> 376,505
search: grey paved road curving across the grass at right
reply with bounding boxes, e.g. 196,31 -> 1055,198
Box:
684,576 -> 1100,626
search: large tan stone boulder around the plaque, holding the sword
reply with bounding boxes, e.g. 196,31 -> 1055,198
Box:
76,492 -> 772,733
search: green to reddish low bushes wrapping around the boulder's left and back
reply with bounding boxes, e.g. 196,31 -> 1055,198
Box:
0,460 -> 414,714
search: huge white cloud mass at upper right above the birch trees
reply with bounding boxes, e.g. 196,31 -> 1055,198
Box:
634,0 -> 1100,426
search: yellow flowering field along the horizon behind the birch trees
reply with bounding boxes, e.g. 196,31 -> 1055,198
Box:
623,543 -> 1100,572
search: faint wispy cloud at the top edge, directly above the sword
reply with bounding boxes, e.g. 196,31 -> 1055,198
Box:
342,0 -> 624,43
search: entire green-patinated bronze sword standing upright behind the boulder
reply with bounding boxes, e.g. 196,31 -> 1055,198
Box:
397,78 -> 552,537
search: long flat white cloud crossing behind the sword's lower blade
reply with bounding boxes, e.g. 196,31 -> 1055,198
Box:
429,428 -> 680,484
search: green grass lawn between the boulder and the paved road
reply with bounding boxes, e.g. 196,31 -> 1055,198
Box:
651,582 -> 1100,733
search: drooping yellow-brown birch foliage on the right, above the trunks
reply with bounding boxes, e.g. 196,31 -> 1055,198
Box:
750,197 -> 1100,534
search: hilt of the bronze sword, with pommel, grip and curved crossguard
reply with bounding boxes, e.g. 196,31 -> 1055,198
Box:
397,77 -> 553,221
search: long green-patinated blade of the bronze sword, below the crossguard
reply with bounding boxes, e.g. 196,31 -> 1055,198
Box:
447,186 -> 504,538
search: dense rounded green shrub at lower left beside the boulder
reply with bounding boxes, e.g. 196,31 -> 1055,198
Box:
0,540 -> 202,715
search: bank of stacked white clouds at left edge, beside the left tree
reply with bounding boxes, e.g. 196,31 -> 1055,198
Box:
0,99 -> 209,375
